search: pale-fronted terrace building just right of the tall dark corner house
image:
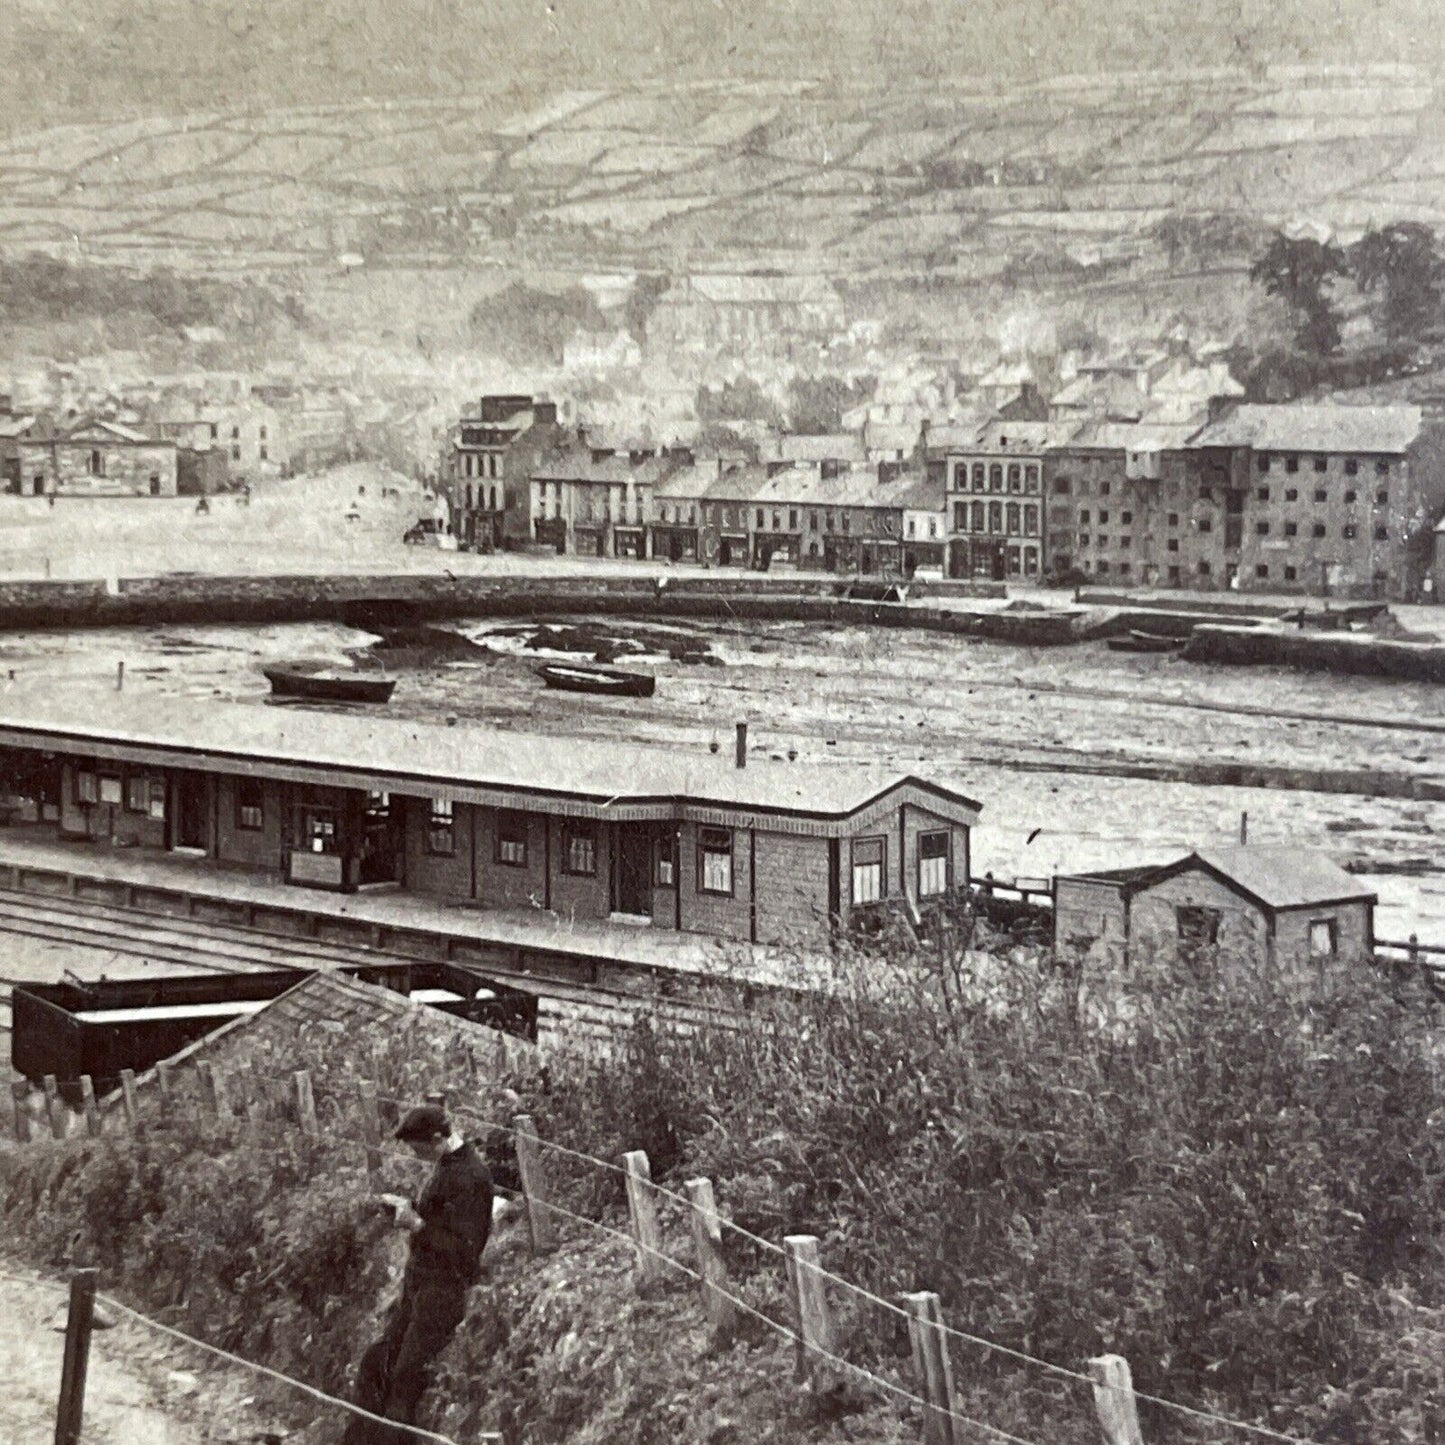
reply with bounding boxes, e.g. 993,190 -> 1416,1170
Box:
527,445 -> 679,558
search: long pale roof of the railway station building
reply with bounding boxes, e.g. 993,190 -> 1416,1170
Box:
0,691 -> 978,832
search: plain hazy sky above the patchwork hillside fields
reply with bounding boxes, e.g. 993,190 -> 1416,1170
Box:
0,0 -> 1441,131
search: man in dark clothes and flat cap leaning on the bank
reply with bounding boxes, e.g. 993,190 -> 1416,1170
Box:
342,1104 -> 491,1445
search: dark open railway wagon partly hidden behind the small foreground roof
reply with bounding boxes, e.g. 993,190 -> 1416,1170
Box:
10,962 -> 538,1104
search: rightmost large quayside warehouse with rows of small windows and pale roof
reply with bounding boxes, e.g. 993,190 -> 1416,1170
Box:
1183,403 -> 1445,601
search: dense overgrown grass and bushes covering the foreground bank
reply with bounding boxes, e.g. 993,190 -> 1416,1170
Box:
0,955 -> 1445,1445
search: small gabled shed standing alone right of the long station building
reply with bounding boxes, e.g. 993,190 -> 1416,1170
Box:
1053,845 -> 1376,971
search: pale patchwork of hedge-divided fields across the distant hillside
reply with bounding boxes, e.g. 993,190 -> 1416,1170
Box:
0,68 -> 1445,289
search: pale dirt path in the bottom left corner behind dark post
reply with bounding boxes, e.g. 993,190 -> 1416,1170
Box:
0,1261 -> 204,1445
